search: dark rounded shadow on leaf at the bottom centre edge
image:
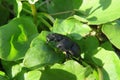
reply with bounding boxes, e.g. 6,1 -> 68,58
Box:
40,69 -> 77,80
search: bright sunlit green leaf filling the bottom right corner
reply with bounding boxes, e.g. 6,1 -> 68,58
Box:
94,45 -> 120,80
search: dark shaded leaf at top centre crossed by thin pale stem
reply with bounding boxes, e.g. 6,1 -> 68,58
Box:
48,0 -> 82,18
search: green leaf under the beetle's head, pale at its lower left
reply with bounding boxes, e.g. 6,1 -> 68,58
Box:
23,31 -> 64,68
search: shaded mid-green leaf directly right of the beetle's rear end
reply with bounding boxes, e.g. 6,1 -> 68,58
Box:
79,36 -> 99,66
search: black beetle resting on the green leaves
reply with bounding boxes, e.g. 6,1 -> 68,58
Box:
47,33 -> 80,58
